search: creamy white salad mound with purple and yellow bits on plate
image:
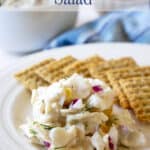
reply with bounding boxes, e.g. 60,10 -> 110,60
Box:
21,74 -> 146,150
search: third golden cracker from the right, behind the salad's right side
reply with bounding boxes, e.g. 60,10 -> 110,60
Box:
89,57 -> 137,85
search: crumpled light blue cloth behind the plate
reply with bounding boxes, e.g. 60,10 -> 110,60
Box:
47,10 -> 150,48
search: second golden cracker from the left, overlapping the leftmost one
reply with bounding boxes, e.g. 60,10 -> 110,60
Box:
36,56 -> 76,83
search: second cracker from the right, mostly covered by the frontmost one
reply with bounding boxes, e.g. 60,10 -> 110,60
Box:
107,67 -> 150,108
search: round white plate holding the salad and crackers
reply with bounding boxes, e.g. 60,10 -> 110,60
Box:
0,44 -> 150,150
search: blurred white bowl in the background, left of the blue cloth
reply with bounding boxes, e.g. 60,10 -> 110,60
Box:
0,8 -> 77,53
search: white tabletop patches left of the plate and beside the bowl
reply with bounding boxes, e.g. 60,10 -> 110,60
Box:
0,8 -> 99,70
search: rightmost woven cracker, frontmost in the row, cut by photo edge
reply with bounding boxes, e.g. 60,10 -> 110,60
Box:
119,76 -> 150,122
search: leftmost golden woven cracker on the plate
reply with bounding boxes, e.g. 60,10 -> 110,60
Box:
15,59 -> 54,90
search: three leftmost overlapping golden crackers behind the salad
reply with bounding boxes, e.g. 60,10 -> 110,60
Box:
15,55 -> 104,90
